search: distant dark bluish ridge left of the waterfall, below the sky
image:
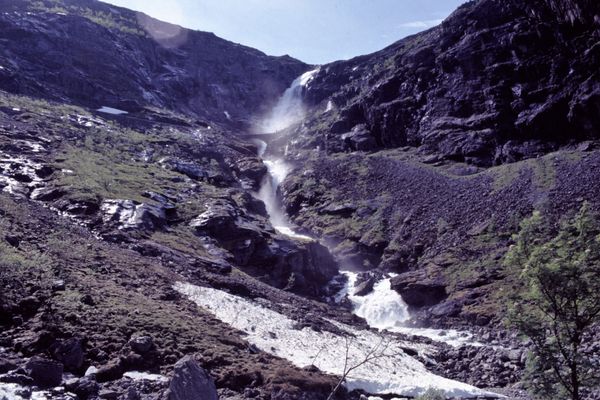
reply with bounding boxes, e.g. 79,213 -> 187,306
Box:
0,0 -> 308,126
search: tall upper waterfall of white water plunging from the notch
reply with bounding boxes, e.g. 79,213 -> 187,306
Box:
254,69 -> 318,240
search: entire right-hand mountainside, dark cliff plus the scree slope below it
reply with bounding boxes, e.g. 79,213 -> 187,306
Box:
281,0 -> 600,325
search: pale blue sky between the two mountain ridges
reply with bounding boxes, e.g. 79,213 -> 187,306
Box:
105,0 -> 464,64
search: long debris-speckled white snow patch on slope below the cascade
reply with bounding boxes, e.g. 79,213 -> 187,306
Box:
174,282 -> 501,397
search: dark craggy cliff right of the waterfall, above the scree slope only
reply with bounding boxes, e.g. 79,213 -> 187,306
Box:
300,0 -> 600,166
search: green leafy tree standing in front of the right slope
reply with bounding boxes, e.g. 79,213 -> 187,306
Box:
506,203 -> 600,400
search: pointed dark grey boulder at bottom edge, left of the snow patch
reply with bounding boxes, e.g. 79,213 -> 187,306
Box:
167,356 -> 218,400
